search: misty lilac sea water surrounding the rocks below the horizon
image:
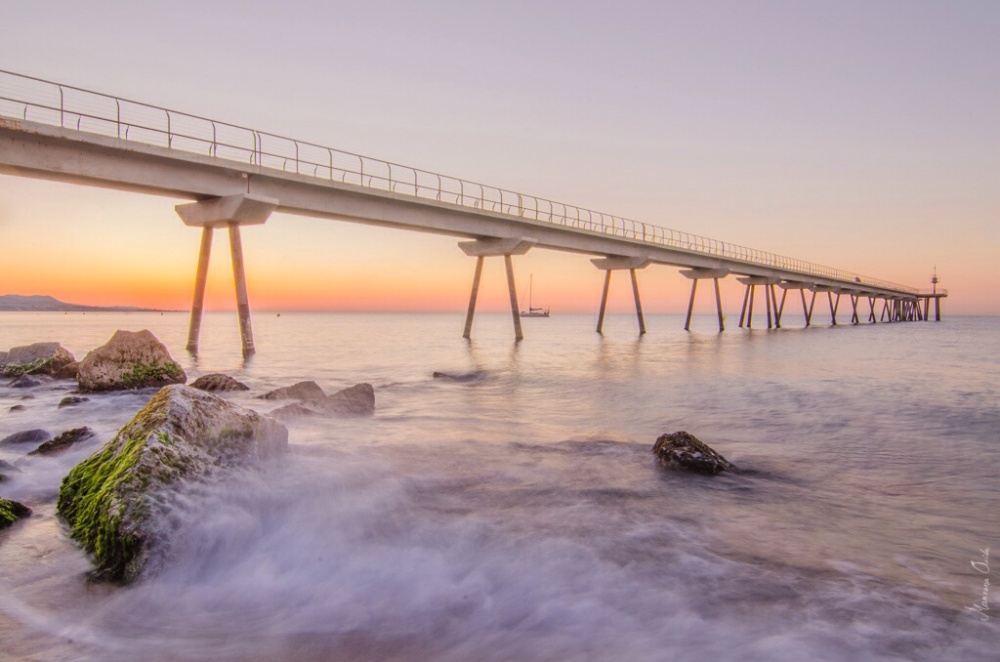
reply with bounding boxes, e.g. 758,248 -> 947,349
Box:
0,313 -> 1000,661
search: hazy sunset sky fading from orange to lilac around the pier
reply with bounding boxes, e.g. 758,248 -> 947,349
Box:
0,0 -> 1000,314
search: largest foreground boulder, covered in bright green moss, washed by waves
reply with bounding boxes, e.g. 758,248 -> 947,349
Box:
57,385 -> 288,582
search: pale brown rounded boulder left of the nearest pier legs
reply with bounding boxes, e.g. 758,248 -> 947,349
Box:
76,330 -> 187,391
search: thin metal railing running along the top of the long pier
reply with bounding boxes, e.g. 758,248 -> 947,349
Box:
0,70 -> 917,295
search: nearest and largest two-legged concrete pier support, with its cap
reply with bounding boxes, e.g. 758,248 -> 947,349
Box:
174,195 -> 278,357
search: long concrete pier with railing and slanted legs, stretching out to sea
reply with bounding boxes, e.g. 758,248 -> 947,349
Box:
0,70 -> 947,355
